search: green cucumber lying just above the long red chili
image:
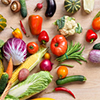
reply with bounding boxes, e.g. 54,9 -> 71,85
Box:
56,75 -> 86,85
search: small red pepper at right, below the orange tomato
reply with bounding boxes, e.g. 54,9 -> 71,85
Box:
86,29 -> 98,43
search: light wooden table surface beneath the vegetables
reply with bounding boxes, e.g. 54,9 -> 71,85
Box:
0,0 -> 100,100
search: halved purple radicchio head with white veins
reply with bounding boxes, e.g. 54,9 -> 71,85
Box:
3,38 -> 27,65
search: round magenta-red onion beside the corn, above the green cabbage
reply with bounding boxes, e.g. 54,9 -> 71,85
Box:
40,59 -> 53,71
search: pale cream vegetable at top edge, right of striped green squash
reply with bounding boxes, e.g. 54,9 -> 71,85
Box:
83,0 -> 94,13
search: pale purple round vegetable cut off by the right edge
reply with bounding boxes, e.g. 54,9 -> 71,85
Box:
89,50 -> 100,63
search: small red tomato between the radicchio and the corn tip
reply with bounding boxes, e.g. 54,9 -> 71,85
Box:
27,42 -> 39,54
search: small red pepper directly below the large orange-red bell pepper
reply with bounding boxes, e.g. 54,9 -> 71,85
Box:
38,30 -> 49,44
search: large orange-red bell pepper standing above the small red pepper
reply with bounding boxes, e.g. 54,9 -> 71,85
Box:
28,15 -> 43,35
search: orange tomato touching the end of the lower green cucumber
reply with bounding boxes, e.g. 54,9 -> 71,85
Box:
57,66 -> 68,79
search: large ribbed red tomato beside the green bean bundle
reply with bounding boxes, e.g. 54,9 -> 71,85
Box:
50,35 -> 67,56
